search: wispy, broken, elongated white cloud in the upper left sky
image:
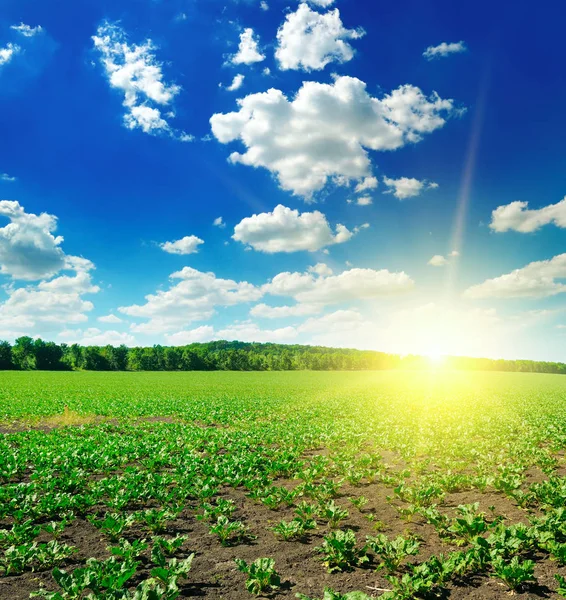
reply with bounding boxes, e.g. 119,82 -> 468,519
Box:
92,21 -> 192,141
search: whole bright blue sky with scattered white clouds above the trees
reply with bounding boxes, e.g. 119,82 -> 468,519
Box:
0,0 -> 566,360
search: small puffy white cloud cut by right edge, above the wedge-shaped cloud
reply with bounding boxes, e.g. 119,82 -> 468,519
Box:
489,197 -> 566,233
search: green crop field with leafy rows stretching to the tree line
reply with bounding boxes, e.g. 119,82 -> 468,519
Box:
0,370 -> 566,600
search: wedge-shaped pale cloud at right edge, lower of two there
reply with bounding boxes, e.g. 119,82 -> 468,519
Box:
464,254 -> 566,298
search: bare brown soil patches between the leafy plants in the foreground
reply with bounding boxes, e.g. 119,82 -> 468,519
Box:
0,474 -> 566,600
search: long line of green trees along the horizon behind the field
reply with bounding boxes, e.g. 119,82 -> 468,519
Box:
0,336 -> 566,375
